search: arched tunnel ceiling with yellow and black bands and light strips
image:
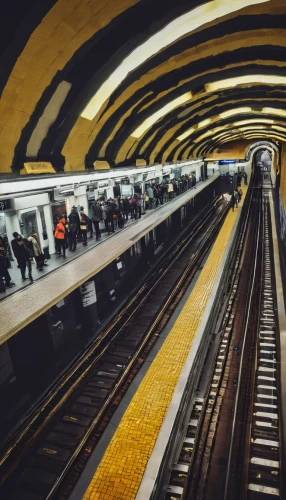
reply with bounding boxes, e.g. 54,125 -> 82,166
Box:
0,0 -> 286,172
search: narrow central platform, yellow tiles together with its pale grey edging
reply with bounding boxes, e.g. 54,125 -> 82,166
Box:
70,188 -> 246,500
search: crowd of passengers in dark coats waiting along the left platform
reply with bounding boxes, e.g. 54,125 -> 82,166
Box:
0,175 -> 196,292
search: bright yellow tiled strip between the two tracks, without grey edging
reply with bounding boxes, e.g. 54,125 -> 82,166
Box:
84,200 -> 244,500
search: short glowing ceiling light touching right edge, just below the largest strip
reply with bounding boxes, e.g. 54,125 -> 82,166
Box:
205,74 -> 286,92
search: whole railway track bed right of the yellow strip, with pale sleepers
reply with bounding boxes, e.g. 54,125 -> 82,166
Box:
174,179 -> 281,500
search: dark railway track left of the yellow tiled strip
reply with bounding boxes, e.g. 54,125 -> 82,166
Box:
0,200 -> 228,500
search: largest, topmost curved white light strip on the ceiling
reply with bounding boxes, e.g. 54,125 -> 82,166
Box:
81,0 -> 269,120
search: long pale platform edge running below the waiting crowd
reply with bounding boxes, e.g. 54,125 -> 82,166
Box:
0,173 -> 220,344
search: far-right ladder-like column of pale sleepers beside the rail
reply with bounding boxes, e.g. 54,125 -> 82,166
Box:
245,190 -> 280,500
